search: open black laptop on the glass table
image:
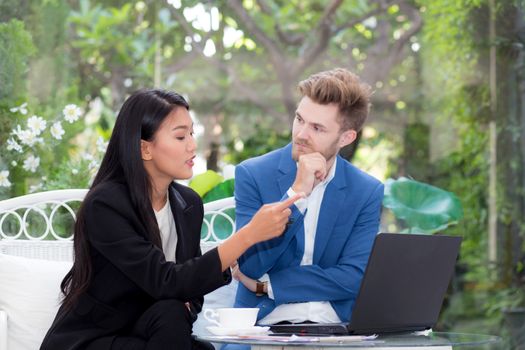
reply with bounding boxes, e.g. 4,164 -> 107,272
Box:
270,233 -> 461,335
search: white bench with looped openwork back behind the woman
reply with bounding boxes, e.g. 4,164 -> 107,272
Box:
0,189 -> 235,350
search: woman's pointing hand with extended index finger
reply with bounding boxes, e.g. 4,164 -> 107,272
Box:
245,193 -> 304,244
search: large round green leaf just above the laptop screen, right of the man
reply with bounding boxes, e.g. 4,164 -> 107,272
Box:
383,177 -> 463,233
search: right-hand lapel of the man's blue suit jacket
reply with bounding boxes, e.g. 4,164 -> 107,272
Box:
313,156 -> 347,264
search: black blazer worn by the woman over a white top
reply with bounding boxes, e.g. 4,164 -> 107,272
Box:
41,182 -> 231,350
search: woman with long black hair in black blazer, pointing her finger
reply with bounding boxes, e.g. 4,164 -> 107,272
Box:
41,90 -> 299,350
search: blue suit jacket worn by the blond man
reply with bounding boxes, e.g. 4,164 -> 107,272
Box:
235,144 -> 383,321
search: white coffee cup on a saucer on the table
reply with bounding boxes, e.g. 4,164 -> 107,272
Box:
204,308 -> 259,329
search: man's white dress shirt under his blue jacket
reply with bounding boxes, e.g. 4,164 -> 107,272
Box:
259,158 -> 341,324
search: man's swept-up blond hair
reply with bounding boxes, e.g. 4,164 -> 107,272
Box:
298,68 -> 371,131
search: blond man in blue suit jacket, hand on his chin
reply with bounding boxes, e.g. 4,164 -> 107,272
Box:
234,68 -> 383,325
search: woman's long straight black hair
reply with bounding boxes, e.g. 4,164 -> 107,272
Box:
60,89 -> 189,307
